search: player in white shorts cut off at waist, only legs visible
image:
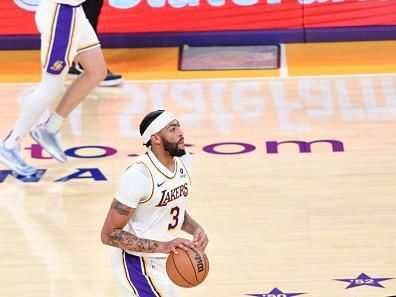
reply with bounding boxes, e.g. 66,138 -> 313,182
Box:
0,0 -> 107,176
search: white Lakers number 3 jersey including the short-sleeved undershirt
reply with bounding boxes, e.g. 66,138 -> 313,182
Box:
115,150 -> 191,257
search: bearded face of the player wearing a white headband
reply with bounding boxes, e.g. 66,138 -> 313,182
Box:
161,120 -> 186,157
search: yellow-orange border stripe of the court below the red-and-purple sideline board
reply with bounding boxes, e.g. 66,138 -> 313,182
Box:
0,41 -> 396,82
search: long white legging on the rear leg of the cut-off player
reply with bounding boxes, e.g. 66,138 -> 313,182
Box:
4,71 -> 67,149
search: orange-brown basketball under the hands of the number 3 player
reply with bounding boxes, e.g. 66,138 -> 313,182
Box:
166,248 -> 209,288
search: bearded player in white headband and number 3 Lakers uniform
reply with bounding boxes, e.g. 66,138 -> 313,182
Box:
101,110 -> 208,297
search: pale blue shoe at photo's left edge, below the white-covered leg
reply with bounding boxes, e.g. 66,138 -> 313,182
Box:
0,141 -> 37,176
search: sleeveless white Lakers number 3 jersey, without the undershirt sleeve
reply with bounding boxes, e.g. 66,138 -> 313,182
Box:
124,151 -> 191,257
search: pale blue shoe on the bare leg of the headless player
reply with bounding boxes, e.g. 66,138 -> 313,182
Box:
30,124 -> 67,163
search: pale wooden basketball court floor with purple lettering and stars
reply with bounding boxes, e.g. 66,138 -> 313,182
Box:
0,43 -> 396,297
